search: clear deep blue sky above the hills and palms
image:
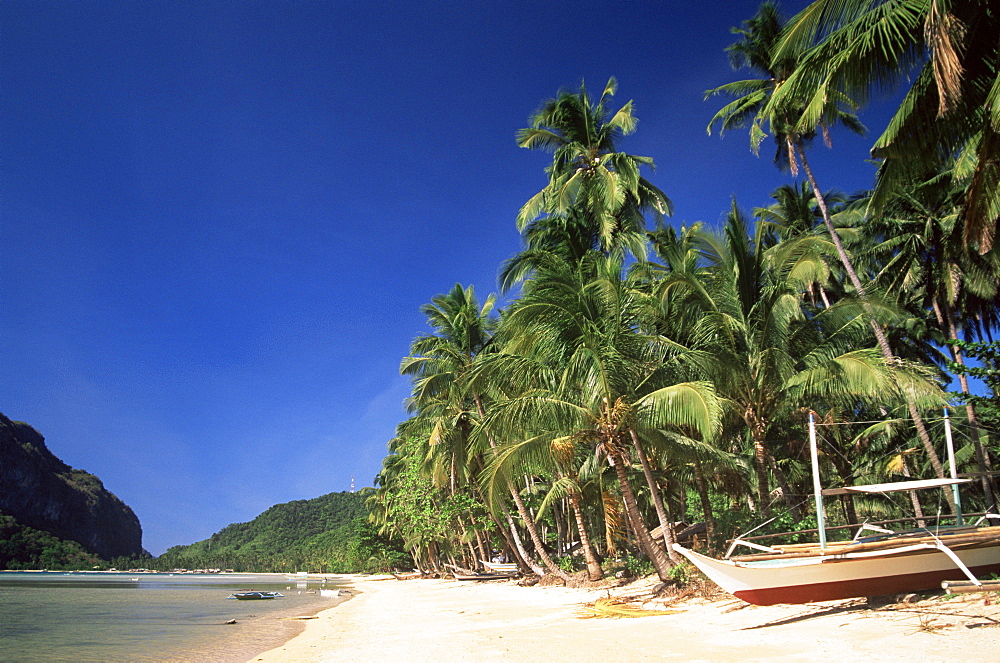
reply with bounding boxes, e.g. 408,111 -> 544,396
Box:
0,0 -> 900,554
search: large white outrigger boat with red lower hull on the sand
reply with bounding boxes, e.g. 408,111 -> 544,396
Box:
674,415 -> 1000,605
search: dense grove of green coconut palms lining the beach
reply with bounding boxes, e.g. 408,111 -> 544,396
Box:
368,0 -> 1000,580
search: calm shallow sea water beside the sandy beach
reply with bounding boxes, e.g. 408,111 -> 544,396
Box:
0,572 -> 352,663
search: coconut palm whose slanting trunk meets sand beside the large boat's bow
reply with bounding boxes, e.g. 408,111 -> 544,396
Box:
474,253 -> 720,580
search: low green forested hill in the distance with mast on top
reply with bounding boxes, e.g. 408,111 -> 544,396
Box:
155,492 -> 403,572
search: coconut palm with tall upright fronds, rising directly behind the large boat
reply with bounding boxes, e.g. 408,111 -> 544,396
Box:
659,203 -> 942,509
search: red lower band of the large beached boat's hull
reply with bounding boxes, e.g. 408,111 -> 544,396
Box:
733,564 -> 1000,605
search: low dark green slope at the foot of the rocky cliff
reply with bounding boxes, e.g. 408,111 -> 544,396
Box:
0,514 -> 104,571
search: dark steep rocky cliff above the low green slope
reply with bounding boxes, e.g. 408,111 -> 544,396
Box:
0,414 -> 148,560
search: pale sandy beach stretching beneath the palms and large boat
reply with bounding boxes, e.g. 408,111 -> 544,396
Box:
251,578 -> 1000,663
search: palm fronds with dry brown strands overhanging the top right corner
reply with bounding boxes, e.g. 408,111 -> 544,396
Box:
776,0 -> 1000,253
